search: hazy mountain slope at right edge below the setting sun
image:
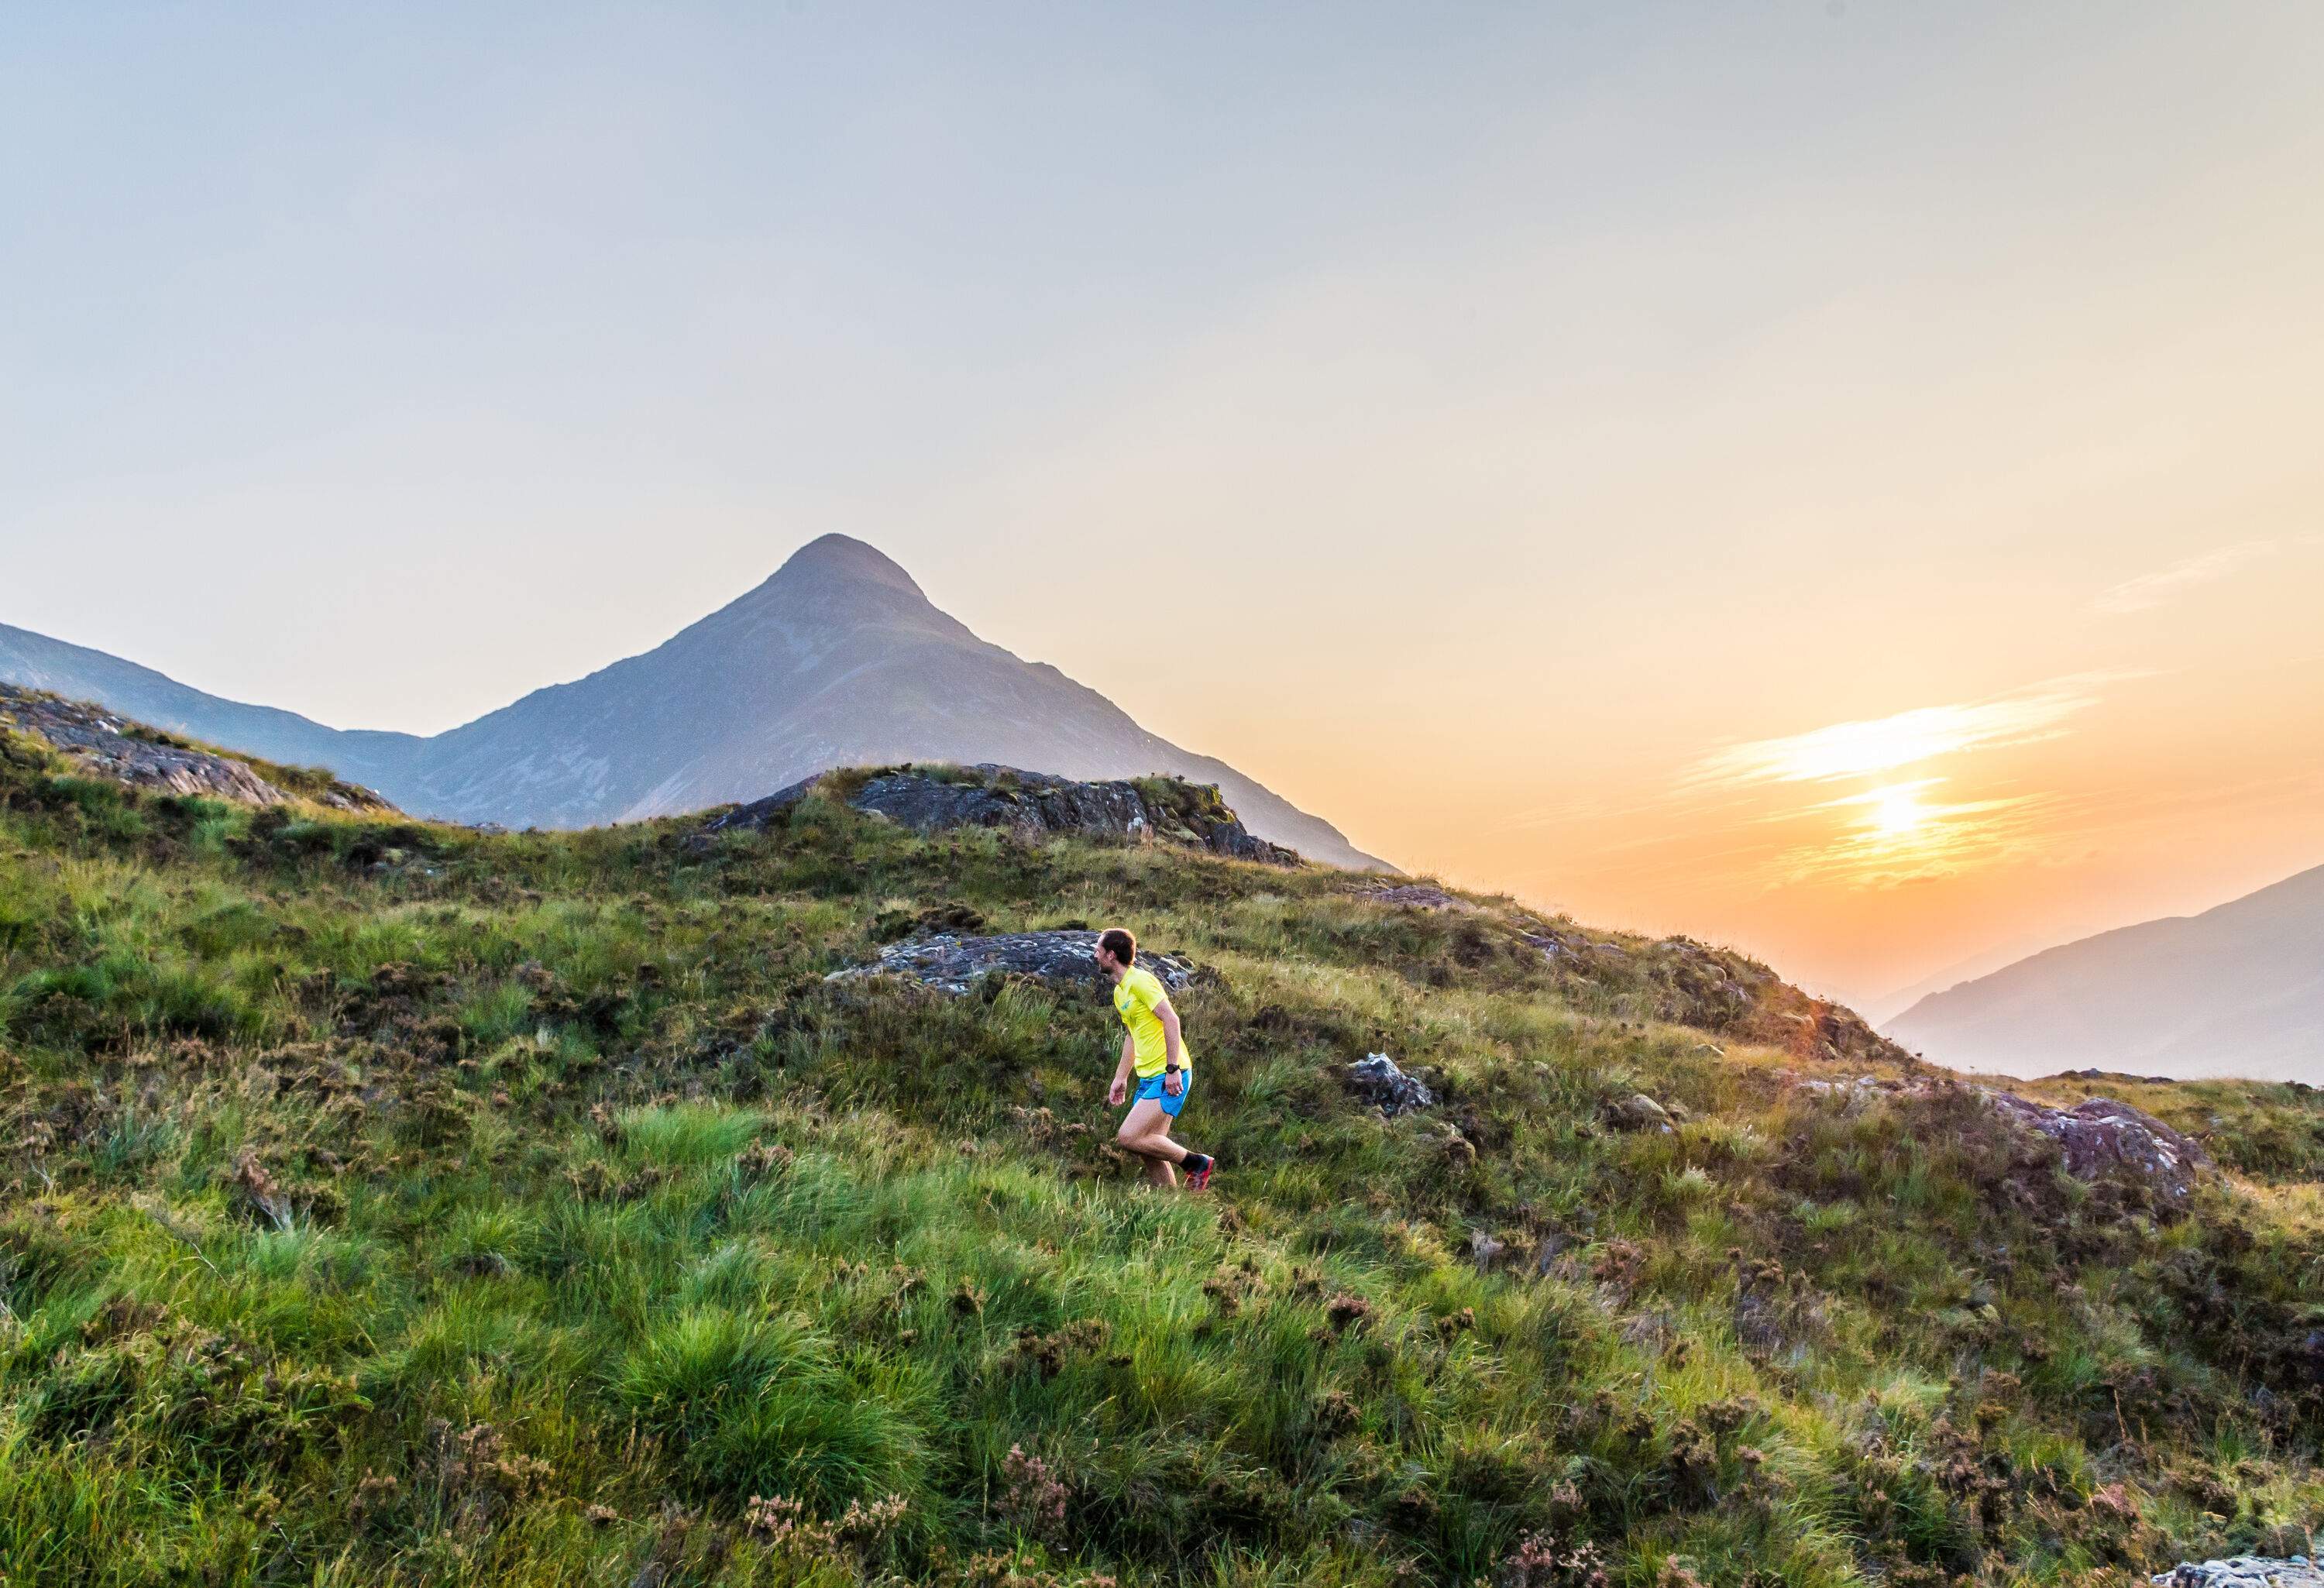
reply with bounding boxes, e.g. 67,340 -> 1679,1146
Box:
1882,865 -> 2324,1084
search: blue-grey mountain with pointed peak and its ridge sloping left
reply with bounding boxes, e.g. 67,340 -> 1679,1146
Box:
0,534 -> 1392,870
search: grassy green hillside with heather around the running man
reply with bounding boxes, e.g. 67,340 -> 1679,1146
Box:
0,739 -> 2324,1588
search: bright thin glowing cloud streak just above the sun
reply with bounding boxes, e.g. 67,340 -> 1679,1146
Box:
1683,672 -> 2140,788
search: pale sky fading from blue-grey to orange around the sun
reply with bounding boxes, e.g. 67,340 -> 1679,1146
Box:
0,0 -> 2324,1000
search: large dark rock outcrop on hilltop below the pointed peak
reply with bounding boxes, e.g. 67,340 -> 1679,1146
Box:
704,762 -> 1299,865
